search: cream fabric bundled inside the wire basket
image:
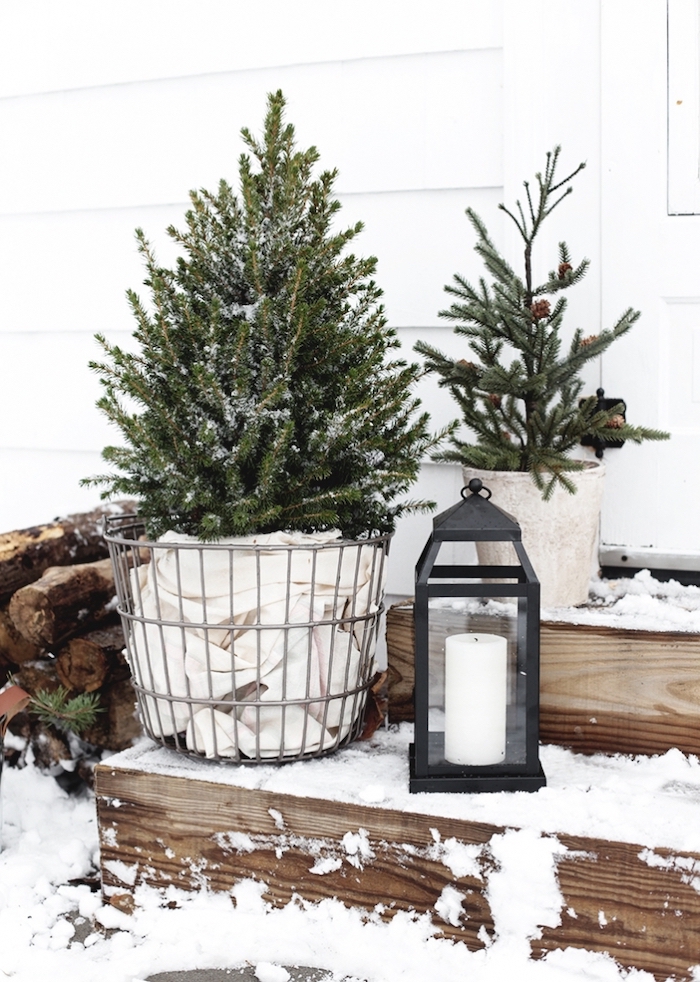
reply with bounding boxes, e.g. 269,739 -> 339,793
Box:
131,531 -> 383,757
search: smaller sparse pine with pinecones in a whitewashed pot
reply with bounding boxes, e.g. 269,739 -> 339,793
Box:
415,147 -> 668,606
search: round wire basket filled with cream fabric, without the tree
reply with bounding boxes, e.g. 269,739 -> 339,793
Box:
105,515 -> 391,763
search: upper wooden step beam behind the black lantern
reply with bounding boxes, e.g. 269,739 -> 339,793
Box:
387,605 -> 700,754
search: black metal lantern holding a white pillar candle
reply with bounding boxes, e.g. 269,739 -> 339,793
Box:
410,478 -> 546,792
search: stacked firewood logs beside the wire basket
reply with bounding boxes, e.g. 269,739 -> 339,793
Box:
0,501 -> 141,769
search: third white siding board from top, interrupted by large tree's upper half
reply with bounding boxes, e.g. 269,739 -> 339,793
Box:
0,188 -> 502,338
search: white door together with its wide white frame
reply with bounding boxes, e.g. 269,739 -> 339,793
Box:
504,0 -> 700,570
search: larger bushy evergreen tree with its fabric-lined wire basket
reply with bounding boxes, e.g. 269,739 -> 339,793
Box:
88,92 -> 435,761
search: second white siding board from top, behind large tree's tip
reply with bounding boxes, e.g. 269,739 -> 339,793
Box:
0,50 -> 502,215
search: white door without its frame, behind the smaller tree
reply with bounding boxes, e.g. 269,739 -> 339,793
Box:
601,0 -> 700,570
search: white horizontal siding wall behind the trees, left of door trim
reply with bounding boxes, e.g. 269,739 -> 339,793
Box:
0,0 -> 503,592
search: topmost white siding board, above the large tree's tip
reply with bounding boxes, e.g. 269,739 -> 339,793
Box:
0,0 -> 503,96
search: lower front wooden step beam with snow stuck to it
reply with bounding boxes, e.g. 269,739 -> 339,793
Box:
95,761 -> 700,982
